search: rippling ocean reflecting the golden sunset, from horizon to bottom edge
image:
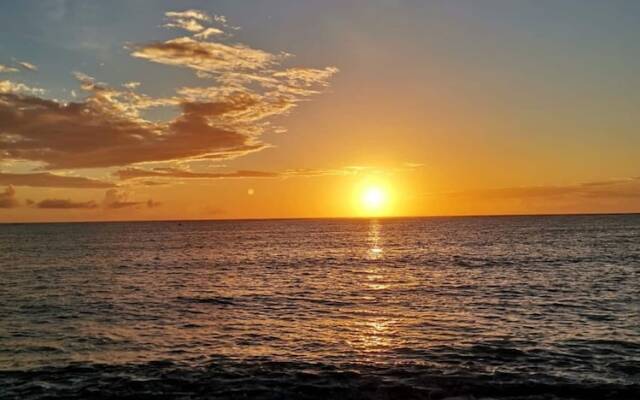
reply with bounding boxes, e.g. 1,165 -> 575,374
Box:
0,215 -> 640,399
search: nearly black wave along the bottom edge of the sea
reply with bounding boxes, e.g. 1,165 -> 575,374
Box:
0,358 -> 640,400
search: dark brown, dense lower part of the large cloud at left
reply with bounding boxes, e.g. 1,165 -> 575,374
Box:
0,93 -> 263,169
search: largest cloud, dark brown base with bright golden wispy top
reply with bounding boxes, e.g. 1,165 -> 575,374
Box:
0,10 -> 337,170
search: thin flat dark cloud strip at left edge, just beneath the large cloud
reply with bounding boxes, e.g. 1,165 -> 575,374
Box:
0,172 -> 115,189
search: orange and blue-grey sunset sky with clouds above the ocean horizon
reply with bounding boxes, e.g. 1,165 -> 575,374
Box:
0,0 -> 640,222
